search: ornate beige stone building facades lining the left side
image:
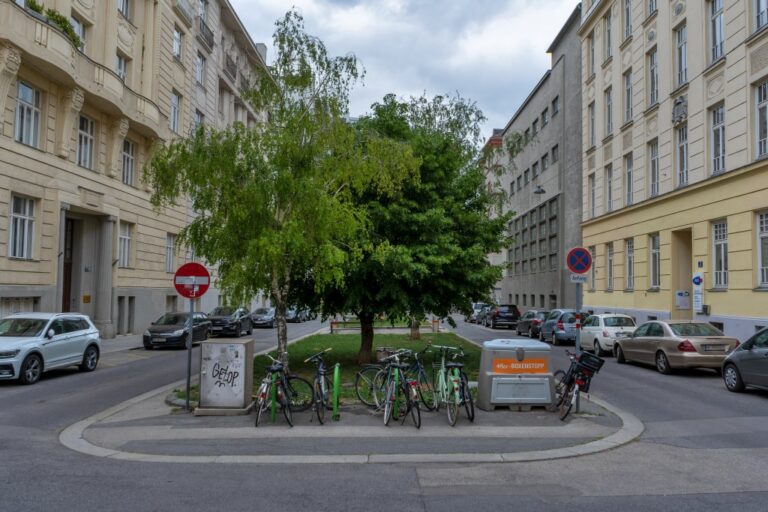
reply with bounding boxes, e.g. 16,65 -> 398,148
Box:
0,0 -> 266,337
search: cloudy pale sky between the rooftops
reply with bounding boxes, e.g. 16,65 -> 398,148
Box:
230,0 -> 578,141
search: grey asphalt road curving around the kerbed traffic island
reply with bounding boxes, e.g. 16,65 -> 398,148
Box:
0,321 -> 768,512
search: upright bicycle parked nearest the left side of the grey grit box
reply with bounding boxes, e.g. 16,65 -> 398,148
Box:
433,345 -> 475,426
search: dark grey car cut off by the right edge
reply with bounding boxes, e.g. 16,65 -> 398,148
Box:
723,327 -> 768,392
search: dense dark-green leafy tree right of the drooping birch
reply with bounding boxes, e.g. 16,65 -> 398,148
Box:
301,95 -> 512,364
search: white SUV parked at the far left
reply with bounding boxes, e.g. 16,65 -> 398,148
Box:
0,313 -> 101,384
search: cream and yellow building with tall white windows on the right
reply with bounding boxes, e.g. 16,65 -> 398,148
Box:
579,0 -> 768,339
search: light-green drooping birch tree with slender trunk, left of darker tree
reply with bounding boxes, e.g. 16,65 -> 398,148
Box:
146,11 -> 414,363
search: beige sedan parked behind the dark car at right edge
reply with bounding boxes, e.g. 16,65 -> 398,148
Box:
614,320 -> 739,373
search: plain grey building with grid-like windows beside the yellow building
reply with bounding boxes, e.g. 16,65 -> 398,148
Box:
488,7 -> 582,310
